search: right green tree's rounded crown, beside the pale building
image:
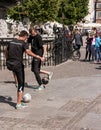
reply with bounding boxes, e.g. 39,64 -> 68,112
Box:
57,0 -> 89,25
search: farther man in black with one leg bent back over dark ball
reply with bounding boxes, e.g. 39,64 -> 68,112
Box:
28,27 -> 53,90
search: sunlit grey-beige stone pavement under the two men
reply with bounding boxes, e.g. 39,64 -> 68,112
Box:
0,47 -> 101,130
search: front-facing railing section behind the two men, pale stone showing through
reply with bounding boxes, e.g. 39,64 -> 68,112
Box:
0,38 -> 55,69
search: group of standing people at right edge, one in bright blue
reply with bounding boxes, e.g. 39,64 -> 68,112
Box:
84,28 -> 101,63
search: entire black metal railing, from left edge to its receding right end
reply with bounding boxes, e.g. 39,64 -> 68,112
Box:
0,32 -> 70,70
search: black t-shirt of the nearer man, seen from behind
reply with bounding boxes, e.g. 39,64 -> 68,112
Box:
7,39 -> 28,63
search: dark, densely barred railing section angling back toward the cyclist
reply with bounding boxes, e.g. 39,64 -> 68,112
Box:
54,29 -> 72,65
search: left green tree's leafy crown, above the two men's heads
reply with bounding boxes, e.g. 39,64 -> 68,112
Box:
8,0 -> 60,23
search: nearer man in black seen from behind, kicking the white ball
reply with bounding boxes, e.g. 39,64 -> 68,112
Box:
6,31 -> 43,109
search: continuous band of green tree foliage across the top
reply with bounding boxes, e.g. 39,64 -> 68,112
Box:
8,0 -> 89,24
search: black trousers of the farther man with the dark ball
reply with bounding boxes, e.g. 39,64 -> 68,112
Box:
31,58 -> 42,85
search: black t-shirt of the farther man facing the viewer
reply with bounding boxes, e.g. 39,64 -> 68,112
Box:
28,34 -> 43,56
